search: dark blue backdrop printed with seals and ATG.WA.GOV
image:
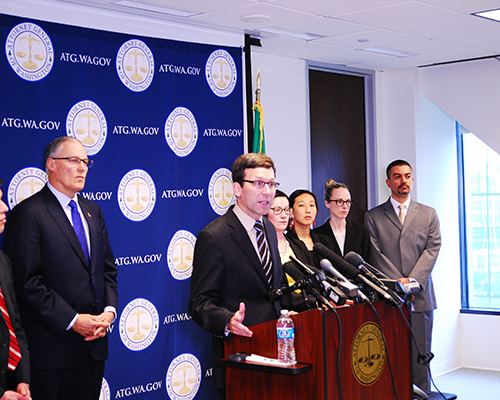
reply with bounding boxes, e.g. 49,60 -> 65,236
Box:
0,14 -> 243,399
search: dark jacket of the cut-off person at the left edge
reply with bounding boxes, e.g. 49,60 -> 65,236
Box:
0,250 -> 30,397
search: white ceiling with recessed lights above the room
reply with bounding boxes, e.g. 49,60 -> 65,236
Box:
55,0 -> 500,70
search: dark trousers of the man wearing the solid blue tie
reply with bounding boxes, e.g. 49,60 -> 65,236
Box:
30,352 -> 104,400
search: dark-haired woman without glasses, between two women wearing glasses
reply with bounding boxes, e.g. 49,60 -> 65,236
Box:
286,189 -> 333,268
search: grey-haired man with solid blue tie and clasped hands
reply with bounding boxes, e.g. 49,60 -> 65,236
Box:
5,137 -> 118,400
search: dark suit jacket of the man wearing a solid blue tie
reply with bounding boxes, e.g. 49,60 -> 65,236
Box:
4,186 -> 118,369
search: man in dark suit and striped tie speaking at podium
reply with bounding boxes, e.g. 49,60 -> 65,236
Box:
189,153 -> 302,398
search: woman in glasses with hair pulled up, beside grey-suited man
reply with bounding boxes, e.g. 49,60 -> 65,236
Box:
313,179 -> 371,263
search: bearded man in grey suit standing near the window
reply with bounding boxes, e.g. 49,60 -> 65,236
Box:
365,160 -> 441,392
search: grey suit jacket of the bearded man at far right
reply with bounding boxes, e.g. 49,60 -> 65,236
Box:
365,198 -> 441,312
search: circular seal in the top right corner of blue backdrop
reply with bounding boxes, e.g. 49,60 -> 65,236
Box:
205,49 -> 238,97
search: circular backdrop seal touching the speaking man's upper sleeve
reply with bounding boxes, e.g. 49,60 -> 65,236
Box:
167,230 -> 196,281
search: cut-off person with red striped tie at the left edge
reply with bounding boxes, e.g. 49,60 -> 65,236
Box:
0,181 -> 31,400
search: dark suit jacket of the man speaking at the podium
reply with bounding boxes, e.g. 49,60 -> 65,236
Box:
188,209 -> 300,389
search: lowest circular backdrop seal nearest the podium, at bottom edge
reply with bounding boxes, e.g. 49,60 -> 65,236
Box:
165,353 -> 201,400
